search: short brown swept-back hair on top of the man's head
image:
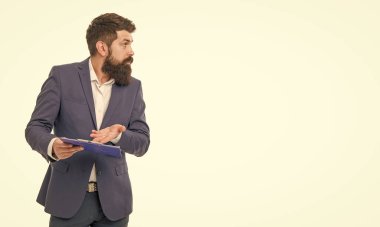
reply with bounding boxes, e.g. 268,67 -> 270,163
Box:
86,13 -> 136,56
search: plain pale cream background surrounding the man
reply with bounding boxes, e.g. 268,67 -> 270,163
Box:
0,0 -> 380,227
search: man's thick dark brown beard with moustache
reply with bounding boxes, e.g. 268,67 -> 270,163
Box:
102,52 -> 133,86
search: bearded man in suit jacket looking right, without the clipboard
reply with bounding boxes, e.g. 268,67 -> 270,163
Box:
25,13 -> 150,227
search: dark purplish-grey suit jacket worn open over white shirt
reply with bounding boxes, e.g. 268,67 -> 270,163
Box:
25,59 -> 150,220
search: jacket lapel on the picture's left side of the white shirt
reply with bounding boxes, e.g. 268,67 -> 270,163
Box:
78,58 -> 97,129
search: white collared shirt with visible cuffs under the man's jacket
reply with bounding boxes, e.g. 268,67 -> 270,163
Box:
48,59 -> 121,181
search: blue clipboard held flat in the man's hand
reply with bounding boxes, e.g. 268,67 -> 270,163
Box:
59,137 -> 122,158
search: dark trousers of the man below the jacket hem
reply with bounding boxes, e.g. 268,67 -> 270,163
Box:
49,192 -> 129,227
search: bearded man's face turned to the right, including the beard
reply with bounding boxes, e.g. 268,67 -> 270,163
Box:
102,30 -> 134,86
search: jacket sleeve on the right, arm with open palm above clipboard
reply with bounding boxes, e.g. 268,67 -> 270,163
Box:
115,82 -> 150,157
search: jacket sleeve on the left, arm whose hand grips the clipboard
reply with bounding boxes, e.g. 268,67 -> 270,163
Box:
25,67 -> 60,161
